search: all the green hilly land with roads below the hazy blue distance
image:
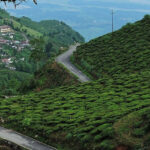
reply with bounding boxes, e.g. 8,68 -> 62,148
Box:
0,2 -> 150,150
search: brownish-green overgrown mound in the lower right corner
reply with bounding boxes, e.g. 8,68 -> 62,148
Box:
114,107 -> 150,150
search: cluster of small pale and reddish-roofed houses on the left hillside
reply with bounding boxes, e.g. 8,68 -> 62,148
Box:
0,25 -> 30,70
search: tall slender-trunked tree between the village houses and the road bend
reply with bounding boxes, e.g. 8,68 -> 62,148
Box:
30,38 -> 46,70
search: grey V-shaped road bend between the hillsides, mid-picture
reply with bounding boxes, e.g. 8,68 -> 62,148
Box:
56,44 -> 90,82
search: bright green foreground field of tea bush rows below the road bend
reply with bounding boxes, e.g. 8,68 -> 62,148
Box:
0,71 -> 150,150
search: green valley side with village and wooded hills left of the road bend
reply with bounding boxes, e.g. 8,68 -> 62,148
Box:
0,9 -> 84,95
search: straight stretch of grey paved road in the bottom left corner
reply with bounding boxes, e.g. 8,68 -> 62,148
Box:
0,127 -> 56,150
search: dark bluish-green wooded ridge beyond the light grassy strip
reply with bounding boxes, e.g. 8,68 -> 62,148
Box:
14,17 -> 84,46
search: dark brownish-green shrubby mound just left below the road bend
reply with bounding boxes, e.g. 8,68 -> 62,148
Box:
20,61 -> 79,93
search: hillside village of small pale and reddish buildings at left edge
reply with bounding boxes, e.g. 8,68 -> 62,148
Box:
0,25 -> 30,70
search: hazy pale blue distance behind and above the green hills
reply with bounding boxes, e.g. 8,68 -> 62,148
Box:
1,0 -> 150,41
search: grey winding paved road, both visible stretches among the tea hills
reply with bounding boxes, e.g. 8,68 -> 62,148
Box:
0,44 -> 90,150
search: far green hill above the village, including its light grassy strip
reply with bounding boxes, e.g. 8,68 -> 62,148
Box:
0,9 -> 84,54
